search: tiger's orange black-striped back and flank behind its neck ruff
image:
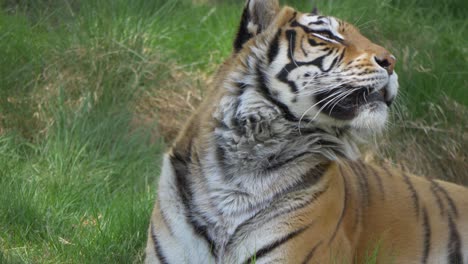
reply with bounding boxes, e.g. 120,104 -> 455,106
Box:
222,161 -> 468,263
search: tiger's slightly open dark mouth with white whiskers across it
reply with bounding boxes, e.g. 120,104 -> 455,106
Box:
316,85 -> 392,120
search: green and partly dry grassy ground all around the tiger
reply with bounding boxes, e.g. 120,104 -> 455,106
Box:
0,0 -> 468,263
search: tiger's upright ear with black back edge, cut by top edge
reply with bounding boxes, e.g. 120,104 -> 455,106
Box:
234,0 -> 280,52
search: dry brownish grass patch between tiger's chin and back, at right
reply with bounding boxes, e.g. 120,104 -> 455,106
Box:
376,97 -> 468,185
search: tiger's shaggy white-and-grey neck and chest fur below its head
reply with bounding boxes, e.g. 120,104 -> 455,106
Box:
166,42 -> 360,254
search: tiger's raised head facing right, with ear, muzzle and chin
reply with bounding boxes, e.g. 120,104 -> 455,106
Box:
229,0 -> 398,135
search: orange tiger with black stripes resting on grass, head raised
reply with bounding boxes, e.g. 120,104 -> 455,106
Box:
145,0 -> 468,264
